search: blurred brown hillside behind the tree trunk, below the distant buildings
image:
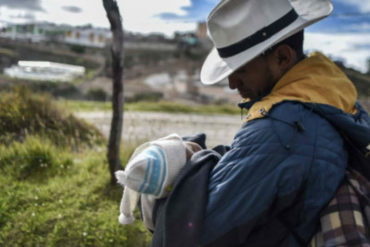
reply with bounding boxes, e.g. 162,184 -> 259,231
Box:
0,39 -> 370,109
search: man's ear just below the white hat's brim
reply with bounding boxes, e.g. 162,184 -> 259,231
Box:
274,44 -> 297,73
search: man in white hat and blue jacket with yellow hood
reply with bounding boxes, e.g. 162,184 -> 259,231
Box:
200,0 -> 370,247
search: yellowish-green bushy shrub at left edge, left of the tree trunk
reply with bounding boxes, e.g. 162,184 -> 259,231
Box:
0,88 -> 104,148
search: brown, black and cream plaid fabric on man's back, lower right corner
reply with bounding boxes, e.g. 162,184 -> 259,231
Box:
309,170 -> 370,247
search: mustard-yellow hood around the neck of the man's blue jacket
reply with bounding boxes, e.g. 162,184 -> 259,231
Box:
246,52 -> 357,121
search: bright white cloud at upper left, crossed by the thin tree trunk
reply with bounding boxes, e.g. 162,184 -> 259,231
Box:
0,0 -> 195,35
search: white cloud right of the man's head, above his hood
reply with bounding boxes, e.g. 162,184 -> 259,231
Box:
304,32 -> 370,72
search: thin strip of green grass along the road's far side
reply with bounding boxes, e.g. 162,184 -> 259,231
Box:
59,100 -> 240,115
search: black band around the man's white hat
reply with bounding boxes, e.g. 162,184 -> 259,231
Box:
217,9 -> 298,58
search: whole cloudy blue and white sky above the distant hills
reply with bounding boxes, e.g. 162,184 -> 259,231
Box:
0,0 -> 370,72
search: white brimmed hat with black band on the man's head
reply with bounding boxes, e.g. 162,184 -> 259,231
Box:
200,0 -> 333,84
